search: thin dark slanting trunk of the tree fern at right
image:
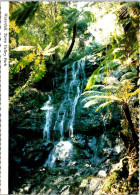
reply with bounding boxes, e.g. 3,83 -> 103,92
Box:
123,102 -> 139,152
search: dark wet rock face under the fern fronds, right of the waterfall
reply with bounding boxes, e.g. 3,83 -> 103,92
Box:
74,94 -> 121,137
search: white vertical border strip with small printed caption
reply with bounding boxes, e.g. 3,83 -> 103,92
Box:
1,2 -> 9,194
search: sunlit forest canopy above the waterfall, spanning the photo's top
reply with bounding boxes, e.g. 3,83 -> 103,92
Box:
9,2 -> 139,114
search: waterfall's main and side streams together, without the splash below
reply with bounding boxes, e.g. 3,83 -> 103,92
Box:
42,58 -> 85,142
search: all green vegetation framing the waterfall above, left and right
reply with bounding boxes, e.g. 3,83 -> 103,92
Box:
9,1 -> 140,194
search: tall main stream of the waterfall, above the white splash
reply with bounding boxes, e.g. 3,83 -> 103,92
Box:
54,59 -> 85,141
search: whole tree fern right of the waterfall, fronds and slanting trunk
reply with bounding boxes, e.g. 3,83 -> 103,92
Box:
84,77 -> 140,152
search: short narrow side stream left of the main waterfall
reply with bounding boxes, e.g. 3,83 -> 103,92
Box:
41,96 -> 53,142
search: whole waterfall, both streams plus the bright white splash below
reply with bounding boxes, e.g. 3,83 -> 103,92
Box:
43,59 -> 85,167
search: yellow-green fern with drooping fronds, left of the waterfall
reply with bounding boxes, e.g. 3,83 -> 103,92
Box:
9,43 -> 59,104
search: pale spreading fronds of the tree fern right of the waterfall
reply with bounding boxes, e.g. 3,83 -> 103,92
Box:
84,77 -> 140,111
